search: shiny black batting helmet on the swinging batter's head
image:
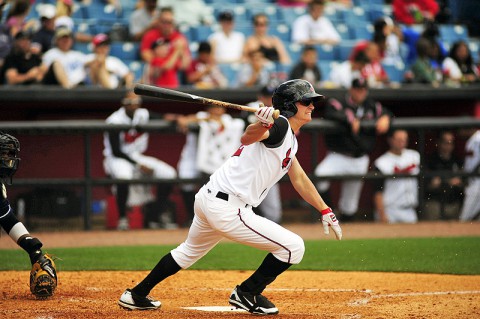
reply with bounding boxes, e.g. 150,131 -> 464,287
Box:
272,79 -> 324,118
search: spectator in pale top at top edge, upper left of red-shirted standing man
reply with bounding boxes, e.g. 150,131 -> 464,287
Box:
128,0 -> 159,41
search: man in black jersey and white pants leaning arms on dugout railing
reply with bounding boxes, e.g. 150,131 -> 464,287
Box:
315,78 -> 392,222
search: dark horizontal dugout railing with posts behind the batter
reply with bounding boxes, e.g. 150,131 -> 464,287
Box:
0,117 -> 480,230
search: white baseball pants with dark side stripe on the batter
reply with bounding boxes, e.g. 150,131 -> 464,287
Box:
171,183 -> 305,269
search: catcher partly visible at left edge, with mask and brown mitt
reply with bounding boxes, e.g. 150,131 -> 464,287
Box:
0,131 -> 57,299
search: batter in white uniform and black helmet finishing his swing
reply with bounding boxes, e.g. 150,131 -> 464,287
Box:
118,79 -> 342,315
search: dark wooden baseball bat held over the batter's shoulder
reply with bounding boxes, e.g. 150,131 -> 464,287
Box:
133,83 -> 280,119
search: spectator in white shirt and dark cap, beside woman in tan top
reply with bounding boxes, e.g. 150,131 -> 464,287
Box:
208,11 -> 245,63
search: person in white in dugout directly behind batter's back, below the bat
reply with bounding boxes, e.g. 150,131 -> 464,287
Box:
170,106 -> 245,224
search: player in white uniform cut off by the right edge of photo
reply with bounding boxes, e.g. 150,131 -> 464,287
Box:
460,130 -> 480,222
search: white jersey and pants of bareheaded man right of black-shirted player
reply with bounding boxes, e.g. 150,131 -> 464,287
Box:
375,149 -> 420,222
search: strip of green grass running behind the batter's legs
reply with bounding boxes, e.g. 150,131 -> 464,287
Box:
0,237 -> 480,275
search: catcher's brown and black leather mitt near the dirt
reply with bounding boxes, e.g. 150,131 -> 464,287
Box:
30,254 -> 57,299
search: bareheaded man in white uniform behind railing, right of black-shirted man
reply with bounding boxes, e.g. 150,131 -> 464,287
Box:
374,130 -> 420,224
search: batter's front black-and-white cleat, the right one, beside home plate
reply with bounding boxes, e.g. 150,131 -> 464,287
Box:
228,286 -> 278,315
